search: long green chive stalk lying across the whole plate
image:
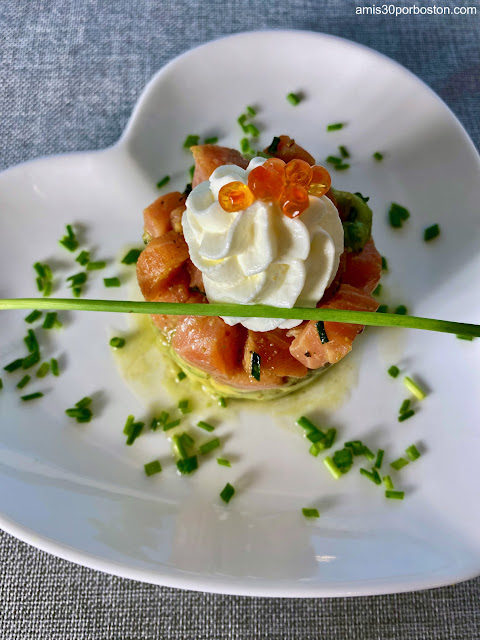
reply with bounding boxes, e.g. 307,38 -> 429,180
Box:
0,298 -> 480,337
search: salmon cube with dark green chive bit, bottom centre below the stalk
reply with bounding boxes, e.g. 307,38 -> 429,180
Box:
243,329 -> 308,379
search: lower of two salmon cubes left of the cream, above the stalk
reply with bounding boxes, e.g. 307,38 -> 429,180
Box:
137,231 -> 189,300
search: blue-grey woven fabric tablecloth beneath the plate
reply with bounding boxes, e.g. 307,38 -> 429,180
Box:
0,0 -> 480,640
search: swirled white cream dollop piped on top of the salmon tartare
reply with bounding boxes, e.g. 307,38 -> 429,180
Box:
182,158 -> 343,331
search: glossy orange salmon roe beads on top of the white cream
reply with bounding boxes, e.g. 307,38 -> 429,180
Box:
218,158 -> 332,218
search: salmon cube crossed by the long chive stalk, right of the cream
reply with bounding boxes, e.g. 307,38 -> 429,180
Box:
290,284 -> 378,369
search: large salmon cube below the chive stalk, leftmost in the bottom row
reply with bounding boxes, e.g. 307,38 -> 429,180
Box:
172,316 -> 246,376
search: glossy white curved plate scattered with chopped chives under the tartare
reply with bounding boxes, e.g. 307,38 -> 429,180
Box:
0,31 -> 480,596
